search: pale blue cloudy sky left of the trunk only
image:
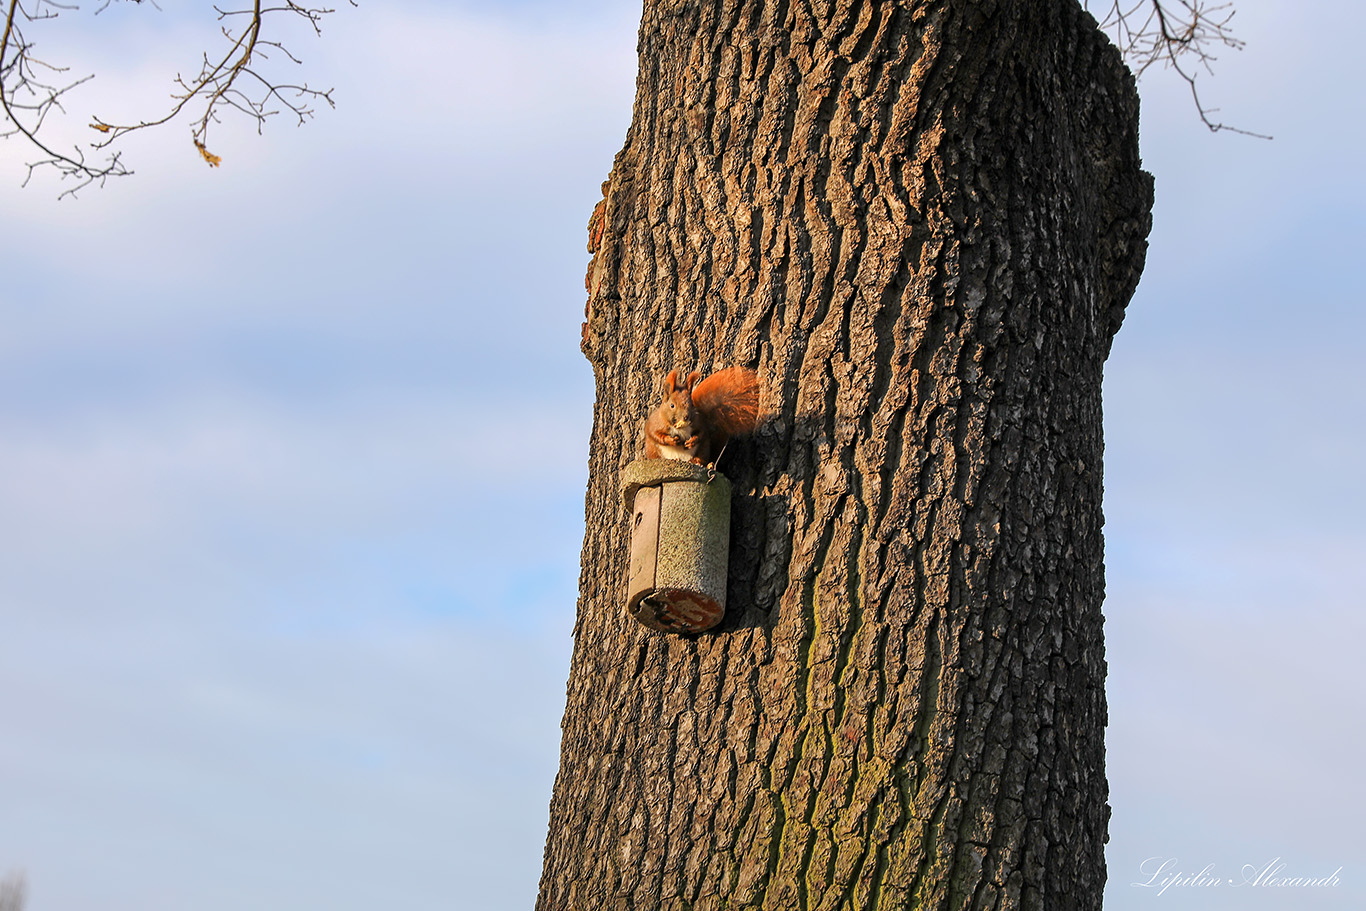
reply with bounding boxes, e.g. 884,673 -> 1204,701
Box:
0,4 -> 634,895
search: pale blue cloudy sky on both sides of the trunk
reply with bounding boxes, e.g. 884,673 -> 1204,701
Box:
0,0 -> 1366,911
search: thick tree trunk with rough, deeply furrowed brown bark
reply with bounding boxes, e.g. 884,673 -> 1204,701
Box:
537,0 -> 1152,911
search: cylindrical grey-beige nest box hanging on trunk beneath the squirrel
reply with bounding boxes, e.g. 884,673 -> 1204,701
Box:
622,459 -> 731,632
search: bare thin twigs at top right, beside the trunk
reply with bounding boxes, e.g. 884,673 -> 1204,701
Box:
1082,0 -> 1270,139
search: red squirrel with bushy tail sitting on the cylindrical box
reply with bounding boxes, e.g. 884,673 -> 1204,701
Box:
645,367 -> 759,464
